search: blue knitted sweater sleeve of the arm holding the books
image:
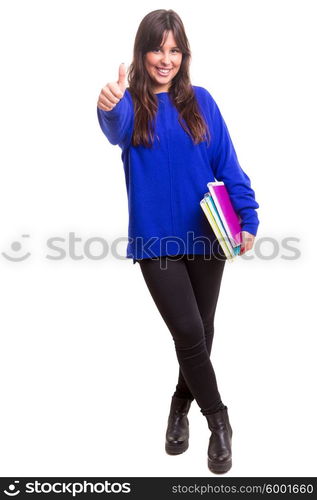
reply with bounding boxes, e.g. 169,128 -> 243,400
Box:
202,90 -> 260,236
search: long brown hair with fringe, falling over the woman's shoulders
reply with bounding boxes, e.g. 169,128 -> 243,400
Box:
127,9 -> 210,147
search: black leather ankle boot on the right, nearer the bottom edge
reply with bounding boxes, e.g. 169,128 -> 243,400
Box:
205,406 -> 232,474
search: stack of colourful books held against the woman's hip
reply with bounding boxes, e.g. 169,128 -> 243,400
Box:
200,181 -> 242,262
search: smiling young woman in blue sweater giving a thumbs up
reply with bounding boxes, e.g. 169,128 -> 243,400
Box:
97,9 -> 259,473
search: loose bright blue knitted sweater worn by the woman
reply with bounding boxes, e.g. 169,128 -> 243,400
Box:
97,85 -> 259,264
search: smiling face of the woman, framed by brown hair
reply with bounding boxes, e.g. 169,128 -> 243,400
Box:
145,31 -> 183,94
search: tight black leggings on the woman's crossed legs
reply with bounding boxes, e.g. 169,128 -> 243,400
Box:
137,254 -> 226,415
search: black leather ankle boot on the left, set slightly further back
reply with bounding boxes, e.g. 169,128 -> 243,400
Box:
165,396 -> 192,455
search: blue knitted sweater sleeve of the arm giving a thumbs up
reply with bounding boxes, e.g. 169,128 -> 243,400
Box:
97,90 -> 134,149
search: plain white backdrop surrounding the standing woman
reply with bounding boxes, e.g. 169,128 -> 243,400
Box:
0,0 -> 317,477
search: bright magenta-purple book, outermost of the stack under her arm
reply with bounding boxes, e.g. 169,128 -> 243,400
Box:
207,181 -> 242,247
